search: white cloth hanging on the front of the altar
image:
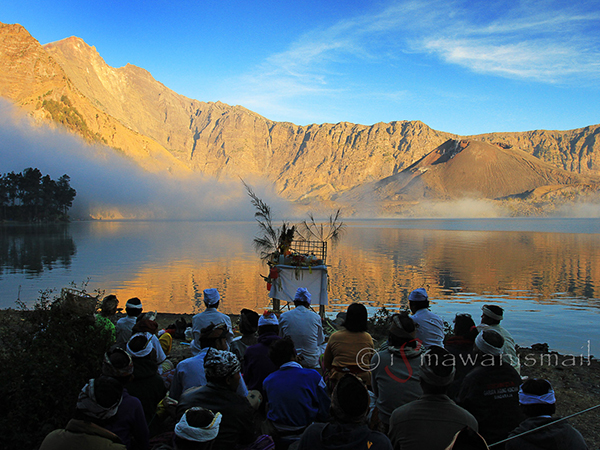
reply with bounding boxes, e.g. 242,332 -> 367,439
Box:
269,265 -> 329,305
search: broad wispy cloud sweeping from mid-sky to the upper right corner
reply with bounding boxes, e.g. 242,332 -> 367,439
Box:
226,0 -> 600,122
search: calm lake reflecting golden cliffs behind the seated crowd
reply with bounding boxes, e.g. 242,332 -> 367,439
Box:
0,219 -> 600,355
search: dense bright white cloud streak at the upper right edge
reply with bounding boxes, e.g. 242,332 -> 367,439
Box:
414,2 -> 600,83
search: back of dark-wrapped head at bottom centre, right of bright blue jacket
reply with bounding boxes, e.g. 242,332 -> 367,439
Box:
331,374 -> 370,423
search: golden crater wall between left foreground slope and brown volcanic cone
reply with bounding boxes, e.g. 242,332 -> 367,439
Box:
45,32 -> 450,200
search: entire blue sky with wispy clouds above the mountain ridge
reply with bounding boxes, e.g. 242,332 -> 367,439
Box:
0,0 -> 600,135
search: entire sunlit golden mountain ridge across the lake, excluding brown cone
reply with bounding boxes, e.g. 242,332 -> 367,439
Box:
0,20 -> 600,202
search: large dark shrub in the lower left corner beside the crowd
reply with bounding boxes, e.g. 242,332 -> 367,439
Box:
0,284 -> 110,449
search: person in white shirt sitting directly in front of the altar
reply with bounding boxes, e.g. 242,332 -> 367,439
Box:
279,288 -> 325,369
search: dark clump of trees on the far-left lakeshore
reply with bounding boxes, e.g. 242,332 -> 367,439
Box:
0,167 -> 77,222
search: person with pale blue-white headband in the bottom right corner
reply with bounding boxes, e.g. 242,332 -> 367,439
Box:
506,378 -> 588,450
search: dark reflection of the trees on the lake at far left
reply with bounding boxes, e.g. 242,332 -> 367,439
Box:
0,224 -> 77,276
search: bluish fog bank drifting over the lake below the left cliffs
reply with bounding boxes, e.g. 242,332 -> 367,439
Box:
0,99 -> 290,220
